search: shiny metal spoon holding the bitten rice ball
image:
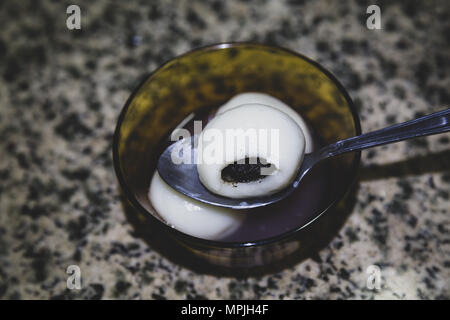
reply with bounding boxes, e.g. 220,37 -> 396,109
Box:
157,108 -> 450,209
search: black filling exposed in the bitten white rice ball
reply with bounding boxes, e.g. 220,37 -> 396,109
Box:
221,157 -> 271,183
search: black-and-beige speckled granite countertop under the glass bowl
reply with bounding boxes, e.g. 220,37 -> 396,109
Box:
0,0 -> 450,299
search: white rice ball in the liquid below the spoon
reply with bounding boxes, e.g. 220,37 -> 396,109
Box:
148,171 -> 245,240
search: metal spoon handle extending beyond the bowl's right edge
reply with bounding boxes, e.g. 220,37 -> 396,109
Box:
318,108 -> 450,160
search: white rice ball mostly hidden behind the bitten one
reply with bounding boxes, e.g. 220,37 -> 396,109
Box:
216,92 -> 313,153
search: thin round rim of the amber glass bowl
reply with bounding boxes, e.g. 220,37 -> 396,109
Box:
112,41 -> 361,249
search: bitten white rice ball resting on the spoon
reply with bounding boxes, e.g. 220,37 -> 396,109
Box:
197,104 -> 305,198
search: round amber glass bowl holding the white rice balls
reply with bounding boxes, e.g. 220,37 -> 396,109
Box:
113,43 -> 360,267
